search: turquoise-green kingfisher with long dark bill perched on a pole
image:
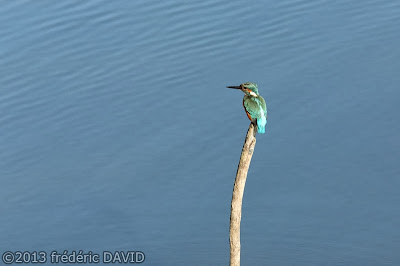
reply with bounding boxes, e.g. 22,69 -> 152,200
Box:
227,82 -> 267,134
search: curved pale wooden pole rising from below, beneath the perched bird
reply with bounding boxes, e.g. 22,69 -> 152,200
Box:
229,123 -> 257,266
